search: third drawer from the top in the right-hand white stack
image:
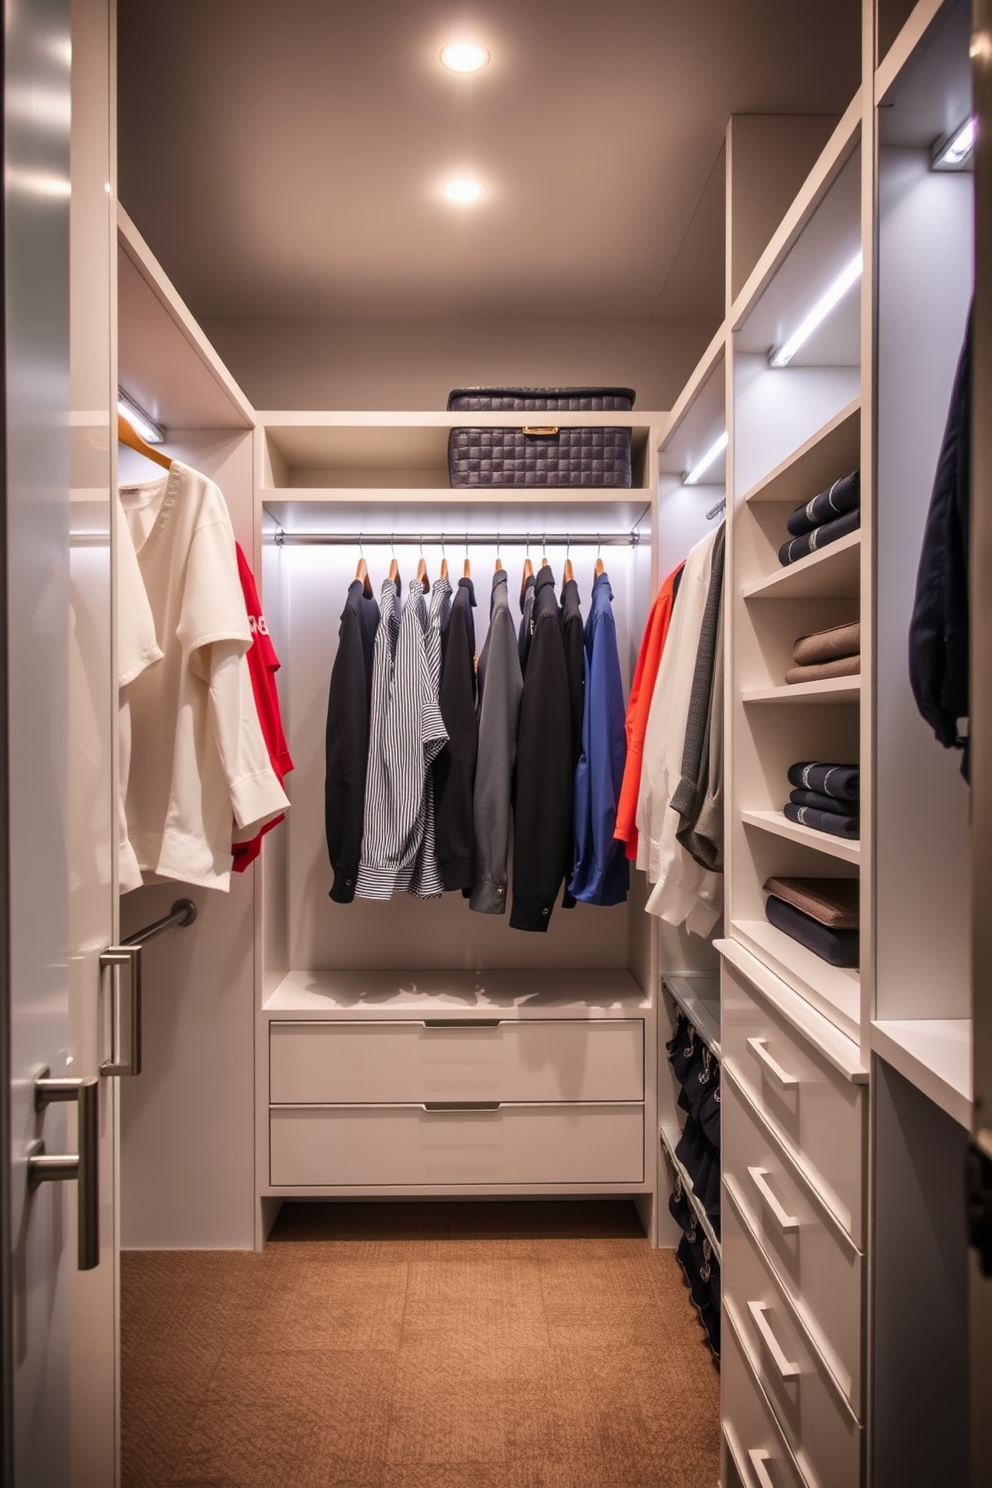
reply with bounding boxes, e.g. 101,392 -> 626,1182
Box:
721,1202 -> 861,1488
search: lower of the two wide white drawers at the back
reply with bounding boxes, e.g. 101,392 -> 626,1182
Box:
269,1106 -> 644,1187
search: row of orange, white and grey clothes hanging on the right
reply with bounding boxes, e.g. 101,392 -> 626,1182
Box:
616,522 -> 726,936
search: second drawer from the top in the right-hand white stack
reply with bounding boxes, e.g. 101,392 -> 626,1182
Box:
721,1071 -> 864,1415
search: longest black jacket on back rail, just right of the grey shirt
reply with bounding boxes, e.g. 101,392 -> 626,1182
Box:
510,567 -> 573,930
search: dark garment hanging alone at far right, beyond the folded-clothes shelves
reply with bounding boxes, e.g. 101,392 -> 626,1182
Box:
909,311 -> 974,780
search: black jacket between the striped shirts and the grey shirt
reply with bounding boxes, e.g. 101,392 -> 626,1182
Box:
433,579 -> 479,888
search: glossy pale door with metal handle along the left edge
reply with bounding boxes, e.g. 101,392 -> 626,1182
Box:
0,0 -> 117,1488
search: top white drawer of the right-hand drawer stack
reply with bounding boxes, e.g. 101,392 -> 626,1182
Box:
720,961 -> 866,1248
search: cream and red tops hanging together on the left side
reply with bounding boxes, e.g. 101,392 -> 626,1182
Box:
116,452 -> 293,893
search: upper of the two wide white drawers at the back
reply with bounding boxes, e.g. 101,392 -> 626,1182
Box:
269,1018 -> 644,1106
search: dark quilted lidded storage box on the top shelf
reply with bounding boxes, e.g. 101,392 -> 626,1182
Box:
448,387 -> 634,488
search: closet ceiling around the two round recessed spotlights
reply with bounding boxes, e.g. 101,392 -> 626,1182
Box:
117,0 -> 861,321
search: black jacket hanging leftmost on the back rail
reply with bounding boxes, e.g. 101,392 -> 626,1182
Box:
324,579 -> 379,905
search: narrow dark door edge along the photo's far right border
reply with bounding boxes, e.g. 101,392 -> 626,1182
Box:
970,0 -> 992,1488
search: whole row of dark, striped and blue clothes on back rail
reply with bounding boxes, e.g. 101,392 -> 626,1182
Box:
324,559 -> 629,931
